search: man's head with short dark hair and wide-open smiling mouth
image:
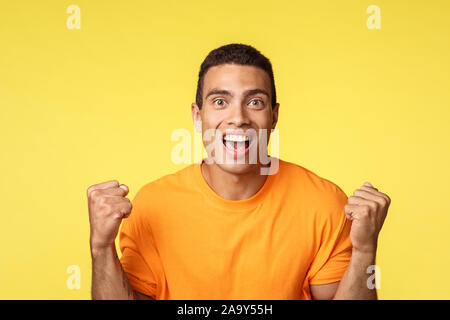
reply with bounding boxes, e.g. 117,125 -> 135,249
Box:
191,44 -> 279,174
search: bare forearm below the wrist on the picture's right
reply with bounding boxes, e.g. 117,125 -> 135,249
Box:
333,250 -> 377,300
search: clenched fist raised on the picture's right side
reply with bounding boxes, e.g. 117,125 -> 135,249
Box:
345,182 -> 391,253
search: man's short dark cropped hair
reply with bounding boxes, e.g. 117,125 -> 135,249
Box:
196,43 -> 277,109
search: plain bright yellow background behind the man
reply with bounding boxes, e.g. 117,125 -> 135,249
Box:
0,0 -> 450,299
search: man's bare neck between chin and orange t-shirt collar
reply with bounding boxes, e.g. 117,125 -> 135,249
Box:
201,163 -> 267,200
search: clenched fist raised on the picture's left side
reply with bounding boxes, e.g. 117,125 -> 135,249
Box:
87,180 -> 131,250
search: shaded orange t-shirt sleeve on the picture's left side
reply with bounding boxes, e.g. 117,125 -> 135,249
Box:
119,192 -> 158,299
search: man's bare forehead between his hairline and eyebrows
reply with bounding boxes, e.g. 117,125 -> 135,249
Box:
203,64 -> 270,93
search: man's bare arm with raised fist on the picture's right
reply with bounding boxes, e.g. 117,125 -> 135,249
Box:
311,182 -> 391,300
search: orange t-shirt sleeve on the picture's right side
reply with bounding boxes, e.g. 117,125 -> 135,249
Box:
308,187 -> 352,285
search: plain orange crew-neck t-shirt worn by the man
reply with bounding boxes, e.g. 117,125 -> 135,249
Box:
120,160 -> 352,299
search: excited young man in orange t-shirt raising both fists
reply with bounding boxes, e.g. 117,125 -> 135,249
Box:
87,44 -> 390,299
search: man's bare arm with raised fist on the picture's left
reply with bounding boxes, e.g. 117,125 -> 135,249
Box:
87,180 -> 153,300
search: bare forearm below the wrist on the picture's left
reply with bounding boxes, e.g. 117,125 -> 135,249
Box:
91,245 -> 136,300
